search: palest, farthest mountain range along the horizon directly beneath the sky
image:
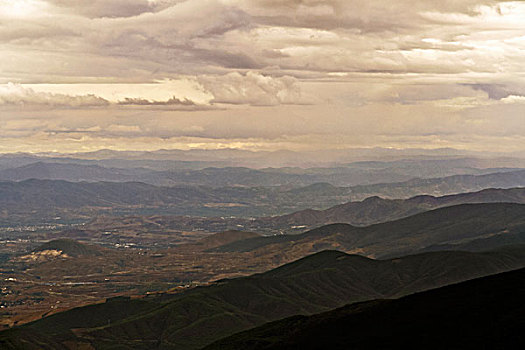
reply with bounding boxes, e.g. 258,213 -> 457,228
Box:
5,148 -> 525,169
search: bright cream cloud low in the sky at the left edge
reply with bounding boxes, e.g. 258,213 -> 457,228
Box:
0,83 -> 109,108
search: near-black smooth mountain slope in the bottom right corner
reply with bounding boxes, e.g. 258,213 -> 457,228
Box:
206,269 -> 525,350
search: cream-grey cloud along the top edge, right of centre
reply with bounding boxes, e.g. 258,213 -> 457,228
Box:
240,0 -> 506,33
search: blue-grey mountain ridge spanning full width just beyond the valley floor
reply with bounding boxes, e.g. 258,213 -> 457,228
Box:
0,170 -> 525,221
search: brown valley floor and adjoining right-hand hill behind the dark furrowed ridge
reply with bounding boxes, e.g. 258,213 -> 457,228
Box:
0,203 -> 525,327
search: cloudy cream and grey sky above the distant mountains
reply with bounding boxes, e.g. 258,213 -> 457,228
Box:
0,0 -> 525,153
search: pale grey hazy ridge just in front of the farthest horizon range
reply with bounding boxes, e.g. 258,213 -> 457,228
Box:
137,159 -> 517,187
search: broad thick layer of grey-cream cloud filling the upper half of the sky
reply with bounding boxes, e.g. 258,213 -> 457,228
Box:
0,0 -> 522,81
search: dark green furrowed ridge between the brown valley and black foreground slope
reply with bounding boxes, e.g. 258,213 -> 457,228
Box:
0,247 -> 525,349
